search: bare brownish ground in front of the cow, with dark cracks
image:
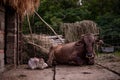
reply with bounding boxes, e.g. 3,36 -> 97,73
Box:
0,54 -> 120,80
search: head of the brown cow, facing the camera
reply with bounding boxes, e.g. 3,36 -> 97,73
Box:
81,33 -> 102,64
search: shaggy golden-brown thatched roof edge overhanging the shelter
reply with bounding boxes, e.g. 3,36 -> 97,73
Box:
0,0 -> 40,15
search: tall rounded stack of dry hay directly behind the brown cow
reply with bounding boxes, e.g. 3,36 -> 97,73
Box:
61,20 -> 99,42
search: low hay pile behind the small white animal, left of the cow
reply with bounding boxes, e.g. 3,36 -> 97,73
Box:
22,34 -> 62,63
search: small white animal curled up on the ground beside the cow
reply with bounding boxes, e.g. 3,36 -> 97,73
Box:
28,57 -> 48,69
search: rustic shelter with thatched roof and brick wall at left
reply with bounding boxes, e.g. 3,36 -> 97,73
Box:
0,0 -> 40,72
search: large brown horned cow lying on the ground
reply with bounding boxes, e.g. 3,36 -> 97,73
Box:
47,33 -> 102,66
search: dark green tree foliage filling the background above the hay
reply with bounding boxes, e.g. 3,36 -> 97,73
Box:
23,0 -> 120,46
